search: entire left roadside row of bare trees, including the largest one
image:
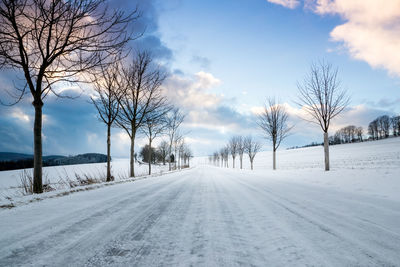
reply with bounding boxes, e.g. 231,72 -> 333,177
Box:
0,0 -> 190,193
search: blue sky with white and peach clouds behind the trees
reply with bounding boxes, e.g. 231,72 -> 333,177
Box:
0,0 -> 400,157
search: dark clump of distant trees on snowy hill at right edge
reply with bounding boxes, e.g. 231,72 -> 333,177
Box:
368,115 -> 400,140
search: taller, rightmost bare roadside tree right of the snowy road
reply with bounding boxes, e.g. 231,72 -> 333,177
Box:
297,61 -> 349,171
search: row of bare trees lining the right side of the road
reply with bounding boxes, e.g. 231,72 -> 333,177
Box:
209,61 -> 346,171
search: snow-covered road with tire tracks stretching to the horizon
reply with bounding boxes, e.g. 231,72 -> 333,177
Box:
0,166 -> 400,266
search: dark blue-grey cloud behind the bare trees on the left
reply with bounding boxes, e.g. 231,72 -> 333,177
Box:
0,0 -> 172,156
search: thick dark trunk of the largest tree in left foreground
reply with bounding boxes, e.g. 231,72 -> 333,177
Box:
33,99 -> 43,194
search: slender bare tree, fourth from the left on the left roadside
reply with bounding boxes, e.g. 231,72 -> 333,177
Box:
140,102 -> 169,175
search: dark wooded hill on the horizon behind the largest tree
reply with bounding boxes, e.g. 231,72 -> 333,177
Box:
0,152 -> 107,171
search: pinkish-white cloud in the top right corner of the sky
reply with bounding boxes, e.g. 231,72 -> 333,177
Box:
268,0 -> 400,76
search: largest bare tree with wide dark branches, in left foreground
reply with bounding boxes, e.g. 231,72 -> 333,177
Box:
0,0 -> 136,193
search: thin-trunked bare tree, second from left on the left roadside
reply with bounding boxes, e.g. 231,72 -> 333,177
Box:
90,62 -> 121,182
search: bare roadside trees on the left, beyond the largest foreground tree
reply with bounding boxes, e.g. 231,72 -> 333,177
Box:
91,58 -> 190,178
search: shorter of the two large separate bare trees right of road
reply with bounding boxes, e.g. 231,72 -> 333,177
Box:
258,99 -> 292,170
